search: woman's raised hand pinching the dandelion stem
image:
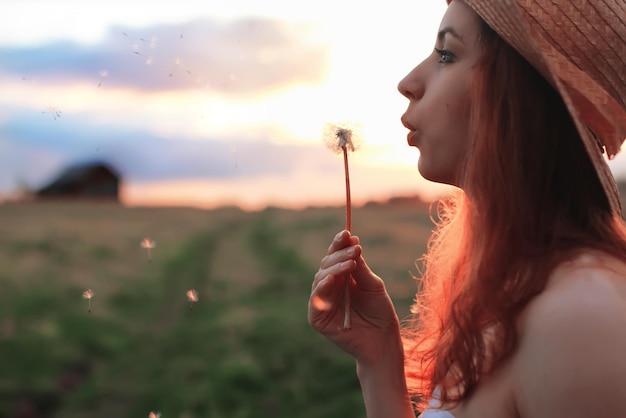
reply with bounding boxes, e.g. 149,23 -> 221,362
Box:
308,231 -> 401,364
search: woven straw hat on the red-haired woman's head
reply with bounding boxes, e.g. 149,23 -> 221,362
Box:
447,0 -> 626,215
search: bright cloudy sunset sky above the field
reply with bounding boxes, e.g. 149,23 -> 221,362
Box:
0,0 -> 625,210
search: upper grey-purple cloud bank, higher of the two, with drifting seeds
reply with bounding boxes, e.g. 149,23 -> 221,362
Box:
0,18 -> 329,95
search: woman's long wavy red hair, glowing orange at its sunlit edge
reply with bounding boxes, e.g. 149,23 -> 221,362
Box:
403,18 -> 626,408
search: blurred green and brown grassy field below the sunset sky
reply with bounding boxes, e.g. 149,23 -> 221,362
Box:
0,203 -> 429,418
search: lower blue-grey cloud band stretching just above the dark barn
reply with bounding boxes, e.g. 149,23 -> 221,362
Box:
0,110 -> 338,192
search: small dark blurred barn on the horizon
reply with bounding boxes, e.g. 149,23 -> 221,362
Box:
35,163 -> 120,201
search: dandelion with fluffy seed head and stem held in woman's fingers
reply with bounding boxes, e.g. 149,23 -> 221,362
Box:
324,124 -> 358,331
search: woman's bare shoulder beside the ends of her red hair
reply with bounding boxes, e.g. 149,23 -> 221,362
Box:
514,254 -> 626,418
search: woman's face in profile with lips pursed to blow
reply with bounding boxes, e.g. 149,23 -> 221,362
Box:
398,0 -> 482,186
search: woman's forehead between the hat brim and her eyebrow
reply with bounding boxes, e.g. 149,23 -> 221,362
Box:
438,0 -> 480,45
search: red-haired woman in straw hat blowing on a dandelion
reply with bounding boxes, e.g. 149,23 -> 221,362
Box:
309,0 -> 626,418
